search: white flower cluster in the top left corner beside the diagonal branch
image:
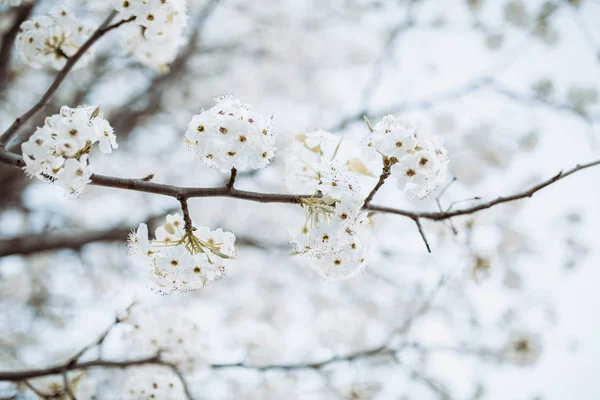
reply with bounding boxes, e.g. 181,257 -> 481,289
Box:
15,7 -> 92,70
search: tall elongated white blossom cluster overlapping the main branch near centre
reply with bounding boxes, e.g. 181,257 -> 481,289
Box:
287,131 -> 371,280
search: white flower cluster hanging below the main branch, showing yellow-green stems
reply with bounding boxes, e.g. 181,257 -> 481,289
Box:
129,214 -> 235,293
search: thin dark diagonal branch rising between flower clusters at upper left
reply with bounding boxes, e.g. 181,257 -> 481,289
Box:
0,10 -> 124,147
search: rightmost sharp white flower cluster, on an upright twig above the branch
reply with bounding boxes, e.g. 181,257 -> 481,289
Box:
364,115 -> 448,198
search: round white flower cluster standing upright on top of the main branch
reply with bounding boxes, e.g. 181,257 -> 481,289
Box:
184,96 -> 275,171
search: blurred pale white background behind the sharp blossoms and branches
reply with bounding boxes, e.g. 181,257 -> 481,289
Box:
0,0 -> 600,400
